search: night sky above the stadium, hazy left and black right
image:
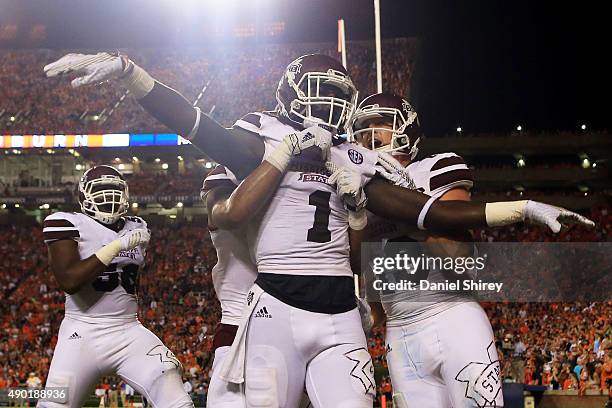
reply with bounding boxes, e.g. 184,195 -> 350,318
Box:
0,0 -> 612,135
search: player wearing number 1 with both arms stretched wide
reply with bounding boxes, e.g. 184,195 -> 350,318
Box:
45,53 -> 588,407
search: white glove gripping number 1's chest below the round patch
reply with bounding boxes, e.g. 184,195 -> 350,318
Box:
325,162 -> 368,231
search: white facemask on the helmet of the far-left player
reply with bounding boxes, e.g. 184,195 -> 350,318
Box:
79,174 -> 129,224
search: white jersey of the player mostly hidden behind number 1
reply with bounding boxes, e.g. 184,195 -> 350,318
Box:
202,166 -> 257,326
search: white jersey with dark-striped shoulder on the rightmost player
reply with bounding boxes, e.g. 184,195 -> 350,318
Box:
367,153 -> 473,327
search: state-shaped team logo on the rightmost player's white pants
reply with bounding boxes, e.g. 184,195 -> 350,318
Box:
455,342 -> 502,408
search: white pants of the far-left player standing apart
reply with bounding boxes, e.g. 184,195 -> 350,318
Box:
37,317 -> 193,408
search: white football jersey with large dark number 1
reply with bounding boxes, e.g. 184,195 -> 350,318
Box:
234,113 -> 378,277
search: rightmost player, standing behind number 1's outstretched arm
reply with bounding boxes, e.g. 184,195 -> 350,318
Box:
349,93 -> 503,408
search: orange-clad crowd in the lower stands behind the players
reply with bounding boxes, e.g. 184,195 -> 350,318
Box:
0,202 -> 612,401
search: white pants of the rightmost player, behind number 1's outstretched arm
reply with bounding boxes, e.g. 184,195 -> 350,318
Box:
386,302 -> 504,408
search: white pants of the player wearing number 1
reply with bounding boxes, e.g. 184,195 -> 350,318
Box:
245,293 -> 376,408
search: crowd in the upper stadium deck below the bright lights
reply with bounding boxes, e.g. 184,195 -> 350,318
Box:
0,38 -> 417,134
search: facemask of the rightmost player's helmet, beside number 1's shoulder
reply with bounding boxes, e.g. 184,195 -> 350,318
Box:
348,104 -> 420,160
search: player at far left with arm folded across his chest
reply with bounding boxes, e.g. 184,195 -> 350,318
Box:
38,166 -> 193,408
